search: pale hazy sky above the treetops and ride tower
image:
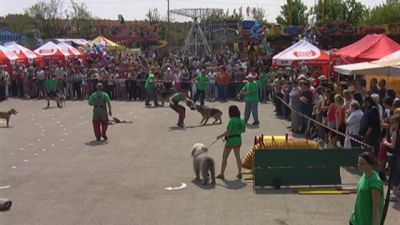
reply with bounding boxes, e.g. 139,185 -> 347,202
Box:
0,0 -> 384,22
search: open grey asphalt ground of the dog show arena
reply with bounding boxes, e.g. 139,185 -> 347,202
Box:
0,99 -> 400,225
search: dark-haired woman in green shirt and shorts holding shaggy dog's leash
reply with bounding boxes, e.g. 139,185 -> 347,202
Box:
217,105 -> 246,179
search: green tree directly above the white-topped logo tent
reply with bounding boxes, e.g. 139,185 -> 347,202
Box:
276,0 -> 309,25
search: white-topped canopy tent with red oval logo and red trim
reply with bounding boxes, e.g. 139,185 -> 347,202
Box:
272,40 -> 330,75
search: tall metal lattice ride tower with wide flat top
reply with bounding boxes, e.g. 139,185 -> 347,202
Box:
169,8 -> 224,56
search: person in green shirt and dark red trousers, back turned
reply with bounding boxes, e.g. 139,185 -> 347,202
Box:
89,83 -> 112,141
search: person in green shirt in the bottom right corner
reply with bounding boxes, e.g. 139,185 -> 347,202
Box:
350,152 -> 384,225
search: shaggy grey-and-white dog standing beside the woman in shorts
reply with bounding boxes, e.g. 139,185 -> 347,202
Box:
192,143 -> 215,185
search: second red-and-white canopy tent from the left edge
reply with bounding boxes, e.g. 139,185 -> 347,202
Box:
4,42 -> 44,66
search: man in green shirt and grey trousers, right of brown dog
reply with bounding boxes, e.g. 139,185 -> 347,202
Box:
238,75 -> 260,126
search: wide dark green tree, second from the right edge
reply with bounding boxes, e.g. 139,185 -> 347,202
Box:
312,0 -> 368,26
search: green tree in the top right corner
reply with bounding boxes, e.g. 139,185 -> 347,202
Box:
365,2 -> 400,24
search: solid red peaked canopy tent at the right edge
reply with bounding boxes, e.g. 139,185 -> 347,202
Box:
331,34 -> 400,63
